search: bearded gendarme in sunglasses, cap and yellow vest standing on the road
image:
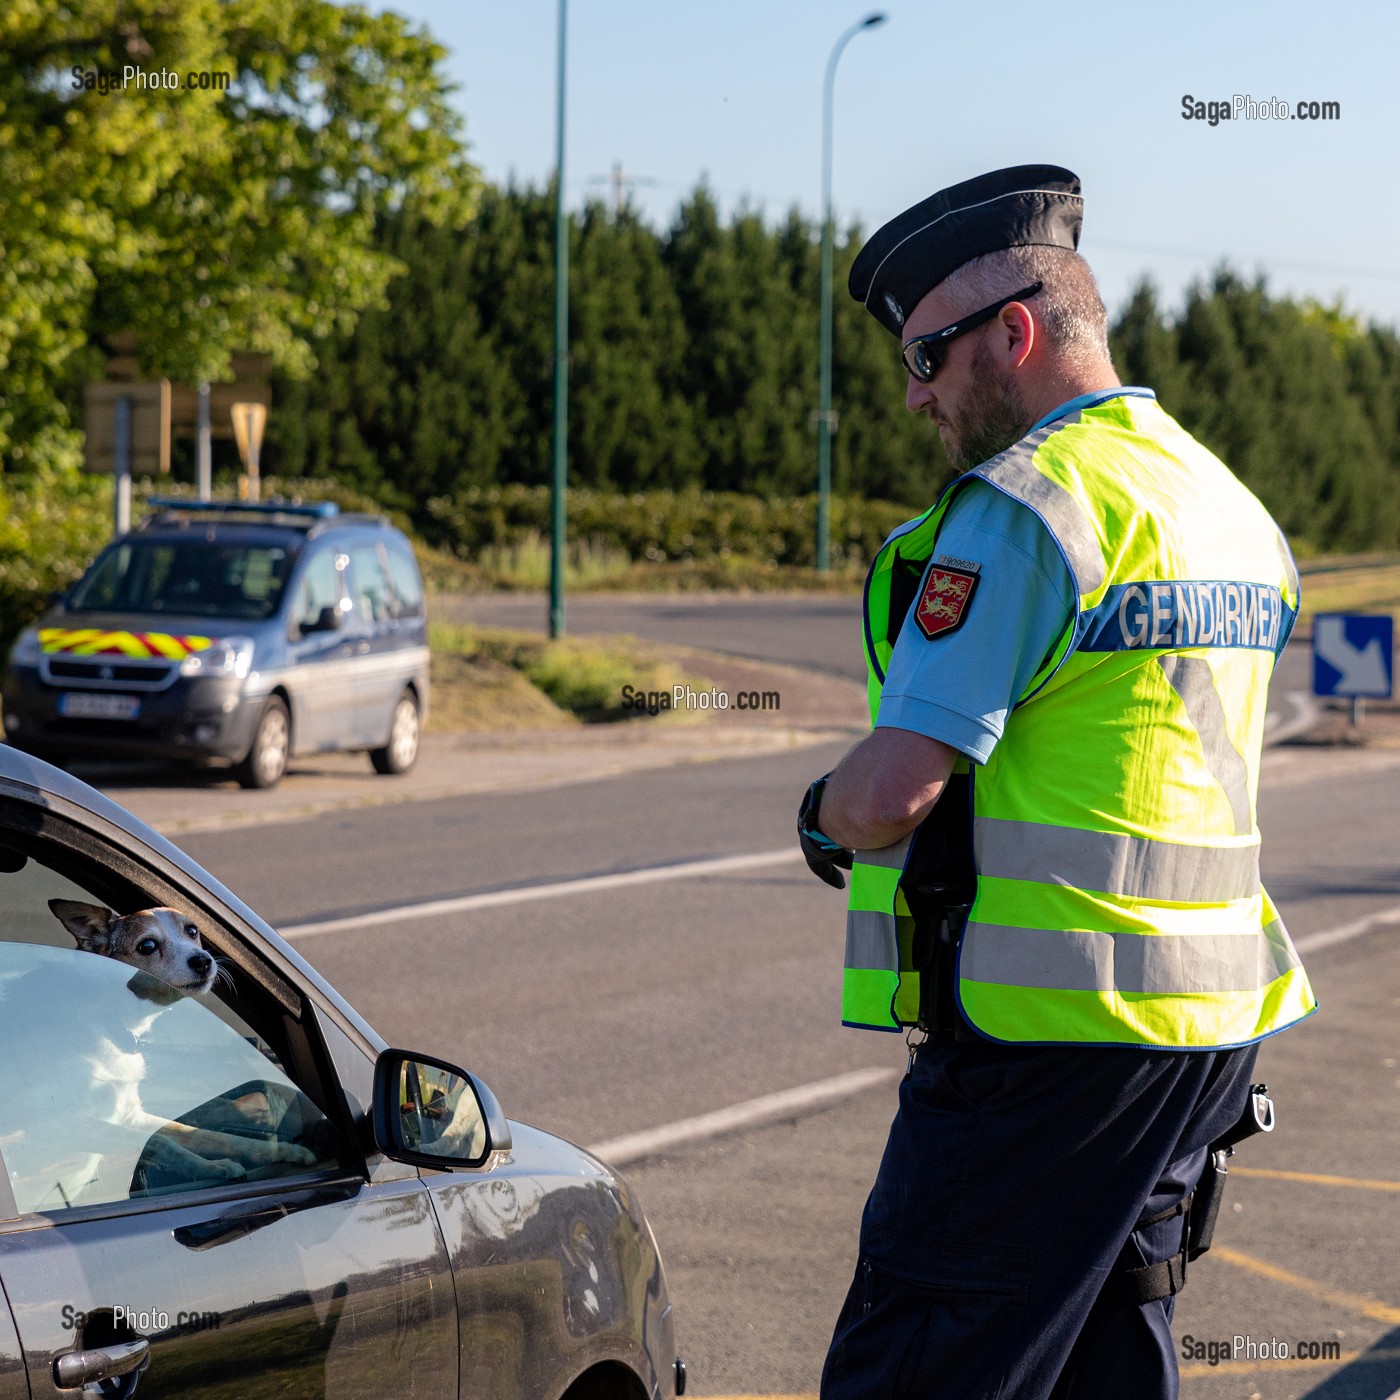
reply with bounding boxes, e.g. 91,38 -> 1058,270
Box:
799,165 -> 1316,1400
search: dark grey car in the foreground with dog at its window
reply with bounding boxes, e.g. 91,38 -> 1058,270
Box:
0,745 -> 685,1400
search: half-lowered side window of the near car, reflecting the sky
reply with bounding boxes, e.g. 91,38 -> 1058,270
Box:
0,848 -> 342,1212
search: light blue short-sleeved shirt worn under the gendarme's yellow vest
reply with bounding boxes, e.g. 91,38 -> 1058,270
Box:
878,388 -> 1152,763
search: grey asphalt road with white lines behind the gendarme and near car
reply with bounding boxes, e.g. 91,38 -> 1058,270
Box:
172,739 -> 1400,1400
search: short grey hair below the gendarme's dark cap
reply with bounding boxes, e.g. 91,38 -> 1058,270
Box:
942,244 -> 1112,368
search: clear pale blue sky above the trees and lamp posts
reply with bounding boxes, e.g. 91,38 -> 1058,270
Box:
378,0 -> 1400,323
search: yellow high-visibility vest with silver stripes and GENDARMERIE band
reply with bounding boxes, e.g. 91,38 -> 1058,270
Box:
841,395 -> 1316,1049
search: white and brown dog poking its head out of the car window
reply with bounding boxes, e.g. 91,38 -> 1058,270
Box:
49,899 -> 316,1186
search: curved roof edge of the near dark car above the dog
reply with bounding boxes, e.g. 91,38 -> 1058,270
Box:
0,743 -> 386,1050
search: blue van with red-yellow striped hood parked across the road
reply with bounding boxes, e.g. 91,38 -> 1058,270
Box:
4,498 -> 428,788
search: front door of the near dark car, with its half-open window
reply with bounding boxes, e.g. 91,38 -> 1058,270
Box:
0,798 -> 458,1400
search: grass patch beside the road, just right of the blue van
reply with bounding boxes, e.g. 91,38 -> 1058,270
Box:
428,622 -> 696,732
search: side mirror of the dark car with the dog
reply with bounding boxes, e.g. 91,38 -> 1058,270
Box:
372,1050 -> 511,1172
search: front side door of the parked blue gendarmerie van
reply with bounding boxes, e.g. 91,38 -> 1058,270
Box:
281,542 -> 367,753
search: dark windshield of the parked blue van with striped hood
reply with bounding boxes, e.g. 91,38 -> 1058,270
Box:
66,539 -> 293,619
